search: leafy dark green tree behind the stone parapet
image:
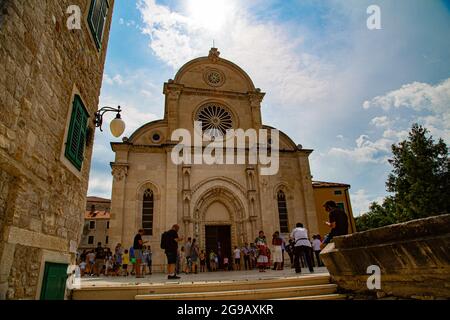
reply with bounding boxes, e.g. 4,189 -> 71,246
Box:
356,124 -> 450,231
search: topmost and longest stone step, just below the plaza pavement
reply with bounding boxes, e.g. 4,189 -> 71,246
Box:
72,274 -> 330,300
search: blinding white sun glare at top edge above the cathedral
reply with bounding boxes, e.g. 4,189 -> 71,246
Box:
187,0 -> 232,32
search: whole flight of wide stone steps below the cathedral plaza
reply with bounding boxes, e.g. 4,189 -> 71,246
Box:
72,274 -> 346,300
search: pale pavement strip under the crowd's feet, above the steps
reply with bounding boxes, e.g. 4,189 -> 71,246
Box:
81,267 -> 328,288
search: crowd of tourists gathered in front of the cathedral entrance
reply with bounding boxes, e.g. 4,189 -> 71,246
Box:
78,201 -> 348,279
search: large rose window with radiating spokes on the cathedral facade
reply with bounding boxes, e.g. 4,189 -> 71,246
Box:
195,103 -> 233,138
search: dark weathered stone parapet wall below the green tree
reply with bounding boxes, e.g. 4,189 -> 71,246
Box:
321,214 -> 450,299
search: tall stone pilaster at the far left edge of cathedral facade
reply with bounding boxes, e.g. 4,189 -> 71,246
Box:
109,162 -> 131,248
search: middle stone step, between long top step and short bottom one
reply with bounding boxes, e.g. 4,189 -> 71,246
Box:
135,284 -> 337,300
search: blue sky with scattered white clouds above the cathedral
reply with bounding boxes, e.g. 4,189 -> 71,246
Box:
88,0 -> 450,216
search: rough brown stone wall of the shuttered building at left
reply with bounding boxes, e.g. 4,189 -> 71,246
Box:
0,0 -> 114,299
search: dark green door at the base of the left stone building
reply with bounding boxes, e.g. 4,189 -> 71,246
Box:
41,262 -> 68,300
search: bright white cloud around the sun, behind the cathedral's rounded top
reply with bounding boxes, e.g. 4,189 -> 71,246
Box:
139,0 -> 330,107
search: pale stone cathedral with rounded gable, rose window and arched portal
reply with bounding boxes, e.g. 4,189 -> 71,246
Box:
110,48 -> 318,271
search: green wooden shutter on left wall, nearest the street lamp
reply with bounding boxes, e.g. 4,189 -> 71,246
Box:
65,95 -> 88,170
